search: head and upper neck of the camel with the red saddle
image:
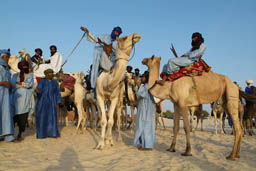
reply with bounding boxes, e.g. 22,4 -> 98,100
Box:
142,55 -> 161,88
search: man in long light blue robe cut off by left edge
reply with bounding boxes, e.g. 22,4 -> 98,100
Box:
0,49 -> 15,142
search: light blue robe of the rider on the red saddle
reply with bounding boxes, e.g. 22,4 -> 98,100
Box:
166,43 -> 206,74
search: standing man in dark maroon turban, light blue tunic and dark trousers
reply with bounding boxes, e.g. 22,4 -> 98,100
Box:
13,61 -> 35,141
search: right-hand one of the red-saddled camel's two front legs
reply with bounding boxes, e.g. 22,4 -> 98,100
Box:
181,107 -> 192,156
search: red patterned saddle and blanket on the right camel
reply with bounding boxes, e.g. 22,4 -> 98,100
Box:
160,57 -> 211,81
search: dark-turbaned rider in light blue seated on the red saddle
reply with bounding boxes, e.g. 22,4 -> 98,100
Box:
157,32 -> 206,85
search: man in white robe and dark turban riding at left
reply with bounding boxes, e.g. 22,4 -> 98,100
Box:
34,45 -> 62,78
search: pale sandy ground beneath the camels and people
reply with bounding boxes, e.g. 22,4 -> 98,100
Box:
0,119 -> 256,171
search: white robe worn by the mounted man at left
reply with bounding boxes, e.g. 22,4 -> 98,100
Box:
34,52 -> 62,77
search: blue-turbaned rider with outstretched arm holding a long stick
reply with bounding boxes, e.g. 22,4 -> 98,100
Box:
81,27 -> 122,89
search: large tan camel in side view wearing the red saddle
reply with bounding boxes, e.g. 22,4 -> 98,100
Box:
142,56 -> 242,160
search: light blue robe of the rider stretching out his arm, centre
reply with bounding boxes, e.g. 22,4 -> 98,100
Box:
87,32 -> 116,88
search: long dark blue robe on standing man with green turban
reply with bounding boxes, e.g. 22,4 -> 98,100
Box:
36,78 -> 61,138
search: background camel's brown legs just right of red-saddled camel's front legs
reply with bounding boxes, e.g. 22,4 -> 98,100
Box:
189,105 -> 204,132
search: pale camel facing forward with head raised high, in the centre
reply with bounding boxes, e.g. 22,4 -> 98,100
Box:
96,33 -> 141,149
